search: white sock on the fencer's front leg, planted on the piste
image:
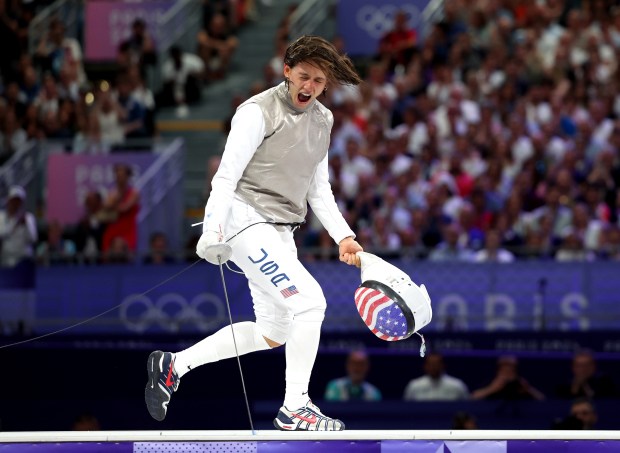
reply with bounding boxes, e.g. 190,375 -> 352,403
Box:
284,320 -> 322,410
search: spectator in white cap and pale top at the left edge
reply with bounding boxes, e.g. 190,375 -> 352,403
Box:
0,186 -> 38,267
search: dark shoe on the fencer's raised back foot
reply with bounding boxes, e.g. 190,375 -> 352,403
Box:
144,351 -> 179,421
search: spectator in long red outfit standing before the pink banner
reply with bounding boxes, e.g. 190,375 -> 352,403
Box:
102,164 -> 140,257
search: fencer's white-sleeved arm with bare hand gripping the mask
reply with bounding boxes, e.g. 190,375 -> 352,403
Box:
308,156 -> 363,265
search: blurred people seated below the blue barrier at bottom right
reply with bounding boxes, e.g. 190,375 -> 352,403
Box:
324,349 -> 620,429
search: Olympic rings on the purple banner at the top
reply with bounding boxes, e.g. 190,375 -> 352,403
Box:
355,3 -> 422,39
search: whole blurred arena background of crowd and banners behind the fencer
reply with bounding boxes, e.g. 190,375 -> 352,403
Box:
0,0 -> 620,431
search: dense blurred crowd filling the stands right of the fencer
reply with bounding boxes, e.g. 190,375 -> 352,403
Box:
294,0 -> 620,262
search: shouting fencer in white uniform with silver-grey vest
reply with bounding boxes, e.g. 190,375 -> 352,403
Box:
145,36 -> 362,431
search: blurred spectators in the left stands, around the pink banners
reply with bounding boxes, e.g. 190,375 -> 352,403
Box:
0,0 -> 257,267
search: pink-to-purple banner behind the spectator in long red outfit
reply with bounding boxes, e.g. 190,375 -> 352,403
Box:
45,152 -> 157,225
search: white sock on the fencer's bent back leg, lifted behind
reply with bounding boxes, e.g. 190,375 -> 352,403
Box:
174,321 -> 269,377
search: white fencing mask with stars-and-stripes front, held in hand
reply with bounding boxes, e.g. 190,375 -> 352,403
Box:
355,252 -> 433,357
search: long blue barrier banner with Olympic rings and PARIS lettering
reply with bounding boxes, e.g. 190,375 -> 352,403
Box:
30,262 -> 620,334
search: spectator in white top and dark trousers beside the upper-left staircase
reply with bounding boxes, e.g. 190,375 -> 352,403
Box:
158,46 -> 205,118
